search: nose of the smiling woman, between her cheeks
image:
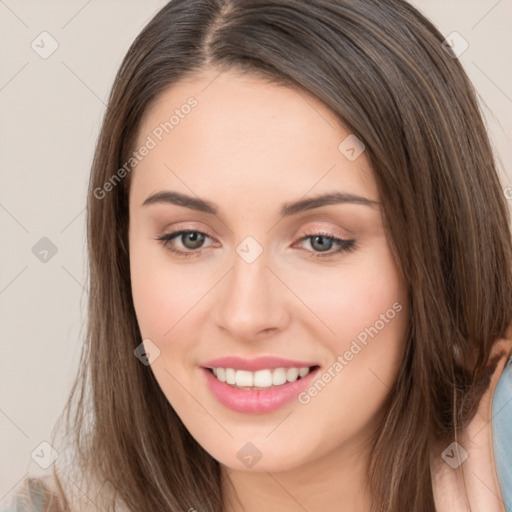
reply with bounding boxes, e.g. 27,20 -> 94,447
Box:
213,248 -> 290,341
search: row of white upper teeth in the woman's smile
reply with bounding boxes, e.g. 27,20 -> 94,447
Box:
212,366 -> 310,388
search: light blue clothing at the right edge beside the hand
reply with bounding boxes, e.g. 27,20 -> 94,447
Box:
492,359 -> 512,512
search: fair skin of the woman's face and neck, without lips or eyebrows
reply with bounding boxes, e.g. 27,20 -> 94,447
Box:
129,70 -> 409,512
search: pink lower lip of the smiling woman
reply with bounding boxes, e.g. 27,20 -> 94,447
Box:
201,367 -> 320,414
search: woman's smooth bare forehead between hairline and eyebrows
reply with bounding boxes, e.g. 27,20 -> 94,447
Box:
131,71 -> 377,208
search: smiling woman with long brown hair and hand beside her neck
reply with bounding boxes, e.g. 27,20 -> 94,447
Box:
5,0 -> 512,512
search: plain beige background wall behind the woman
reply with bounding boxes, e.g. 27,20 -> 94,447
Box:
0,0 -> 512,500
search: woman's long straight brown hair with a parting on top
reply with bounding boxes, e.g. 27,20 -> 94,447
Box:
8,0 -> 512,512
